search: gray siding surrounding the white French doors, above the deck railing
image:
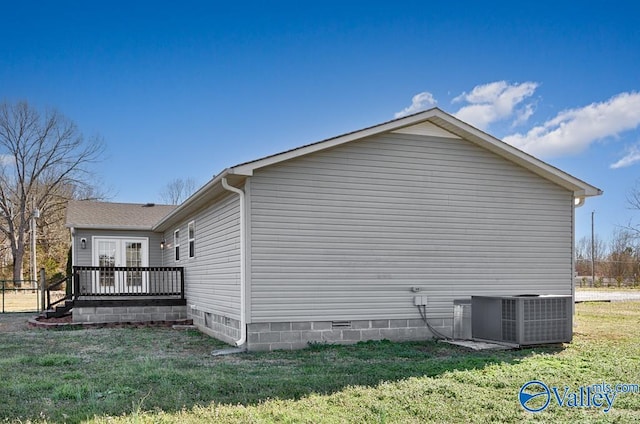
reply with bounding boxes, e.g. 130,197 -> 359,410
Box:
73,229 -> 162,266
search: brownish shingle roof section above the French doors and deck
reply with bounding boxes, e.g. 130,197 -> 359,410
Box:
66,200 -> 176,230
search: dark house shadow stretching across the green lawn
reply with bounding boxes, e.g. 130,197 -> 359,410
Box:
0,322 -> 562,422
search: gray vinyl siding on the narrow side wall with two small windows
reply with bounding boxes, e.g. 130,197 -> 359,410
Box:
165,194 -> 240,320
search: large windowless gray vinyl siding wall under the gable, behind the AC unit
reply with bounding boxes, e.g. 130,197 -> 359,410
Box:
250,134 -> 573,322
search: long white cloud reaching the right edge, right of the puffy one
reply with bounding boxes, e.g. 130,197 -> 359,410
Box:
504,92 -> 640,157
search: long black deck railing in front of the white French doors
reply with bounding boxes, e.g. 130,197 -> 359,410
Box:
73,266 -> 184,299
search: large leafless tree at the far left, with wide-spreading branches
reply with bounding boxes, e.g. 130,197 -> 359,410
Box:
0,102 -> 103,280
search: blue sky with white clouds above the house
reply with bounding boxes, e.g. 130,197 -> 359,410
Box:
0,0 -> 640,243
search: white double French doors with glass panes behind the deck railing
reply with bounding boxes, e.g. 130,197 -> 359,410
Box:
93,237 -> 149,295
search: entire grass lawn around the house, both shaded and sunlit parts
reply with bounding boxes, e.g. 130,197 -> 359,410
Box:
0,302 -> 640,423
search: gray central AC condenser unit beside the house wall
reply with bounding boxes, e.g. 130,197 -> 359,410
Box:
471,295 -> 573,346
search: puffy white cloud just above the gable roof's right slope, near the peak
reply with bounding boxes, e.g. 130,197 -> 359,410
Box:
453,81 -> 539,129
